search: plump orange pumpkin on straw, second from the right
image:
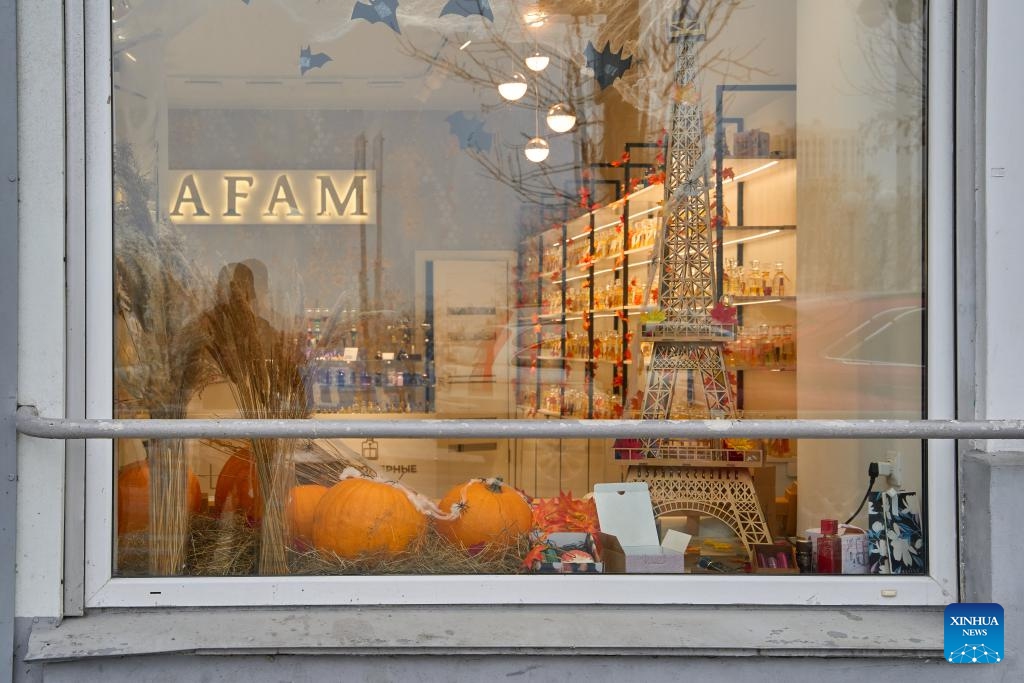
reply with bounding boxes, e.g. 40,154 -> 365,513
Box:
313,478 -> 427,559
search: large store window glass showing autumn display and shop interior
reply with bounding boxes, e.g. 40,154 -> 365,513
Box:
90,0 -> 951,599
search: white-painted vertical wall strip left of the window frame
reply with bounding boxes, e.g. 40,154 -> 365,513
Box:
15,0 -> 66,616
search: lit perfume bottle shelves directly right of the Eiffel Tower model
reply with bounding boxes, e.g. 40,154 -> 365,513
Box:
712,96 -> 800,430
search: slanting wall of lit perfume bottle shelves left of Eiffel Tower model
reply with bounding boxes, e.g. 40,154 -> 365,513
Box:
517,166 -> 665,418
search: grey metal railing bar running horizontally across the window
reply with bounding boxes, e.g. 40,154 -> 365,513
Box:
16,405 -> 1024,439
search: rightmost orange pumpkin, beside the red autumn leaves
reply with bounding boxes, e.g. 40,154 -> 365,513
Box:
435,479 -> 534,550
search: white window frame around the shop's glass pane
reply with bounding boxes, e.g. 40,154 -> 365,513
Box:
81,0 -> 958,607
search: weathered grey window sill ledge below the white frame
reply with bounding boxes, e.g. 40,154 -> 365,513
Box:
25,605 -> 943,661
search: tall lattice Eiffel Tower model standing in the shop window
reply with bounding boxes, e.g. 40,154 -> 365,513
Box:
627,14 -> 771,551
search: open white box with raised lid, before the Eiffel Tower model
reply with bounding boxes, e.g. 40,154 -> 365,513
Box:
594,481 -> 690,573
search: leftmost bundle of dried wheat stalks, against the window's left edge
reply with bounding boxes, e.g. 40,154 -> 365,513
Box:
114,146 -> 212,575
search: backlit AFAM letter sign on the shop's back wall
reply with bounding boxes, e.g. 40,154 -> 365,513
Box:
166,170 -> 377,225
